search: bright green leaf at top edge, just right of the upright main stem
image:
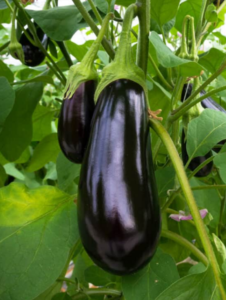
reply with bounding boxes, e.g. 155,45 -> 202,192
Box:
151,0 -> 180,26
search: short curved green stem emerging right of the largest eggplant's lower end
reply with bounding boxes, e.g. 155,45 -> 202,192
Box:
161,229 -> 208,266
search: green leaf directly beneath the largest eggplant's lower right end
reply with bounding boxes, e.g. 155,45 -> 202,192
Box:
122,249 -> 179,300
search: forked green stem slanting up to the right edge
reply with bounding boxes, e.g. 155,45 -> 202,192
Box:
169,62 -> 226,122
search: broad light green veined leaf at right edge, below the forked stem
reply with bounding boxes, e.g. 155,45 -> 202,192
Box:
187,109 -> 226,157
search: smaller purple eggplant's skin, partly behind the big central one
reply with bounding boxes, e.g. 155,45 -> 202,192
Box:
58,80 -> 96,164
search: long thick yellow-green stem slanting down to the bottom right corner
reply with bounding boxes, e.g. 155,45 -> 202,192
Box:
150,119 -> 226,300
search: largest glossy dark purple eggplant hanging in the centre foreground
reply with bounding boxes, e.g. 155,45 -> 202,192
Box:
78,79 -> 161,275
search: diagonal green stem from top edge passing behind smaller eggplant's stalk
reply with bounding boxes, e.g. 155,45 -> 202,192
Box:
72,0 -> 115,59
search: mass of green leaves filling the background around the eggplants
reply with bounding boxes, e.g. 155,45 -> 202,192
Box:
0,0 -> 226,300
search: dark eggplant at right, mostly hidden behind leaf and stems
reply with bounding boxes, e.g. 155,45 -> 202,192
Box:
181,83 -> 213,177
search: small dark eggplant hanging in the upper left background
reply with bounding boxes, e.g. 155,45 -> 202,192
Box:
19,23 -> 49,67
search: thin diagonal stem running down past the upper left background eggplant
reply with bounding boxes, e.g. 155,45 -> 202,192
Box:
13,0 -> 66,85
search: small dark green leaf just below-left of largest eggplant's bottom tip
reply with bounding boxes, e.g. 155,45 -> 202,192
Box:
84,266 -> 117,286
